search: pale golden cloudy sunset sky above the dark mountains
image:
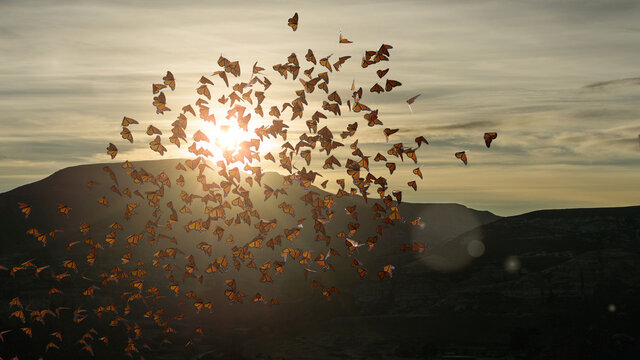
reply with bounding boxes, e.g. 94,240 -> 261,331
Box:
0,0 -> 640,216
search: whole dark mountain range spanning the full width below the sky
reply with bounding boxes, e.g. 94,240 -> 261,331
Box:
0,160 -> 640,359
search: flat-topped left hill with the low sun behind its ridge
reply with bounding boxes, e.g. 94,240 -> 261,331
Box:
0,160 -> 500,358
